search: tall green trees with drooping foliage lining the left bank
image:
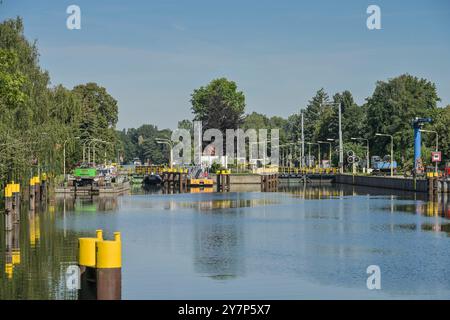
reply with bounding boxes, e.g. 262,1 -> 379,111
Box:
0,17 -> 118,184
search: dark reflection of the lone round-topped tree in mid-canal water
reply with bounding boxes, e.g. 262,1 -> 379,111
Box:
194,213 -> 244,279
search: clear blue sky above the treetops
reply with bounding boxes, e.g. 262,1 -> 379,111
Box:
0,0 -> 450,129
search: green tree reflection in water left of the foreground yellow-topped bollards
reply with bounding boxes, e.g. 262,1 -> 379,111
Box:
0,210 -> 77,299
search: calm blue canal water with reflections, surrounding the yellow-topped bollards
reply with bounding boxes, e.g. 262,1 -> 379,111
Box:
0,185 -> 450,299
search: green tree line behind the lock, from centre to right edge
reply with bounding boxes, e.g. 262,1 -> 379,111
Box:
122,74 -> 450,169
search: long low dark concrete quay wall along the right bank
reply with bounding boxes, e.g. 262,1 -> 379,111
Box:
335,175 -> 428,192
